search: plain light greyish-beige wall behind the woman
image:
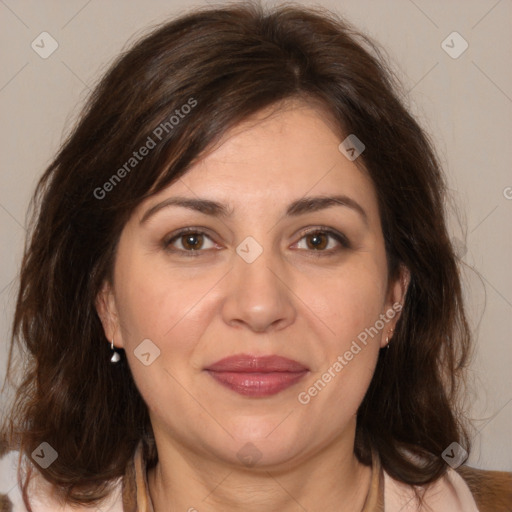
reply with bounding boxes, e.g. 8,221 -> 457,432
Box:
0,0 -> 512,500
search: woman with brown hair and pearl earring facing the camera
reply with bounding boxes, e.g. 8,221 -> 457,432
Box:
1,4 -> 511,512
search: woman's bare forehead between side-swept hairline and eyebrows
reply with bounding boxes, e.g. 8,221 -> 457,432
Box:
134,101 -> 378,225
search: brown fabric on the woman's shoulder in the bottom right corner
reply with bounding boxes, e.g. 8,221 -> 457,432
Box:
457,466 -> 512,512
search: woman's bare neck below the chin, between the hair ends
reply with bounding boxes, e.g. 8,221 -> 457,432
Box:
148,428 -> 371,512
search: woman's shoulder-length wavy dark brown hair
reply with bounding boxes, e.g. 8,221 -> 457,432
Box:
1,2 -> 470,510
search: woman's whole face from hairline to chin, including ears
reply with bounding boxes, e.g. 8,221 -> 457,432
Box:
97,99 -> 405,465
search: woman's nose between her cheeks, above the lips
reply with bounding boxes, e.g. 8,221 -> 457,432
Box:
222,250 -> 296,332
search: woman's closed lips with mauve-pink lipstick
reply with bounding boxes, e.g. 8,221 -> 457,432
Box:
205,354 -> 309,398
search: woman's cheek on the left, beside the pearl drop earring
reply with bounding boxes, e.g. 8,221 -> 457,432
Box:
113,257 -> 218,417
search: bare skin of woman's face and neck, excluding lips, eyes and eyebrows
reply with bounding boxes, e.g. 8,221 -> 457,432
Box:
97,101 -> 408,512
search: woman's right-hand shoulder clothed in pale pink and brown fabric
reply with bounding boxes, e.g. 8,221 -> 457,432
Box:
384,466 -> 512,512
